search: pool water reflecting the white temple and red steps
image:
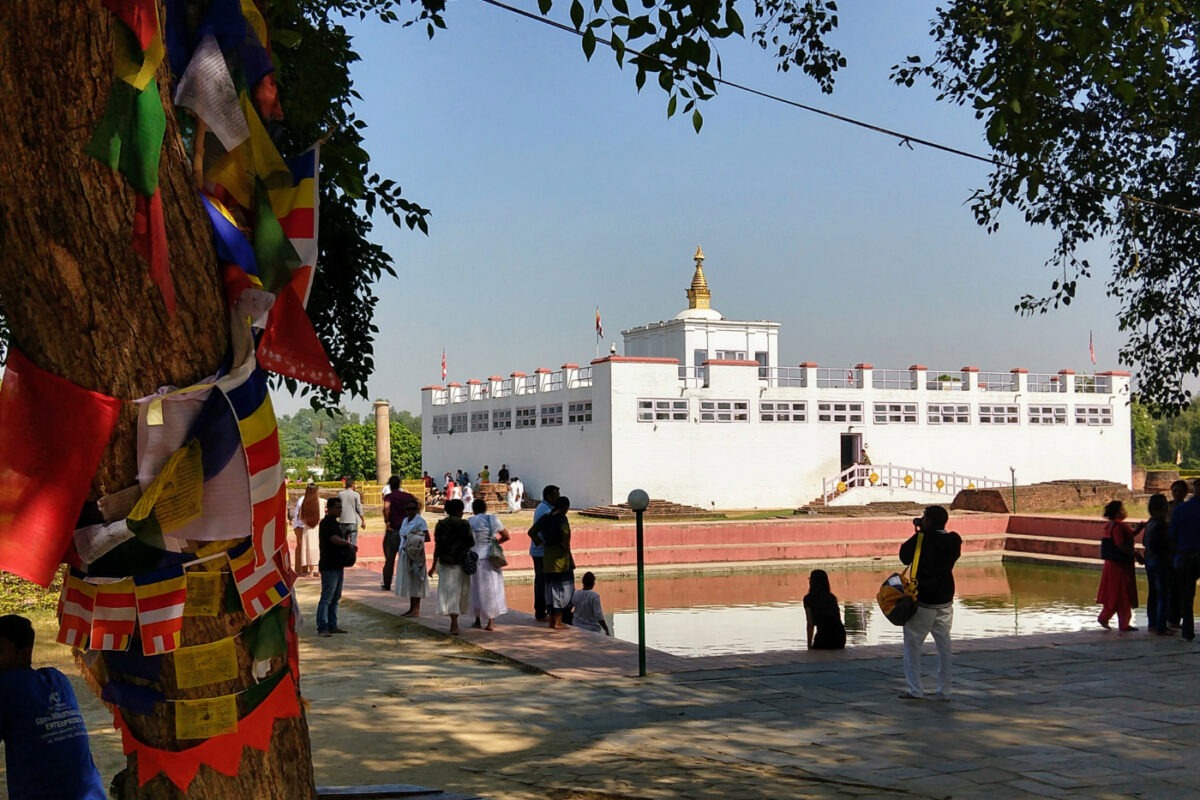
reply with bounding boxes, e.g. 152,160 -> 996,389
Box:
571,563 -> 1146,656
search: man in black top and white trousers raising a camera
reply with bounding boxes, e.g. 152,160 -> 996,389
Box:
900,506 -> 962,699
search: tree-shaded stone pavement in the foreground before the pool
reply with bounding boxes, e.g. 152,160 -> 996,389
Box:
298,570 -> 1200,800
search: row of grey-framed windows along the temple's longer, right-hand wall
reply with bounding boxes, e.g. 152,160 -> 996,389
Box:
637,398 -> 1112,426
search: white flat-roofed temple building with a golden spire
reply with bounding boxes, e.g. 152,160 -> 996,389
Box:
421,247 -> 1132,509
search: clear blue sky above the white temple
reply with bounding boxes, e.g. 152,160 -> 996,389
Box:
276,0 -> 1122,413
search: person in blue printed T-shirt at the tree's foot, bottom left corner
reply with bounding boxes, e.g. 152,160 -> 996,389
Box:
0,614 -> 108,800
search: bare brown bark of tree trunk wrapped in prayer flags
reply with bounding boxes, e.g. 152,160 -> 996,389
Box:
0,6 -> 314,800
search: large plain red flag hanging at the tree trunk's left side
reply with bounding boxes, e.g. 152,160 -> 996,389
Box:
0,348 -> 120,587
